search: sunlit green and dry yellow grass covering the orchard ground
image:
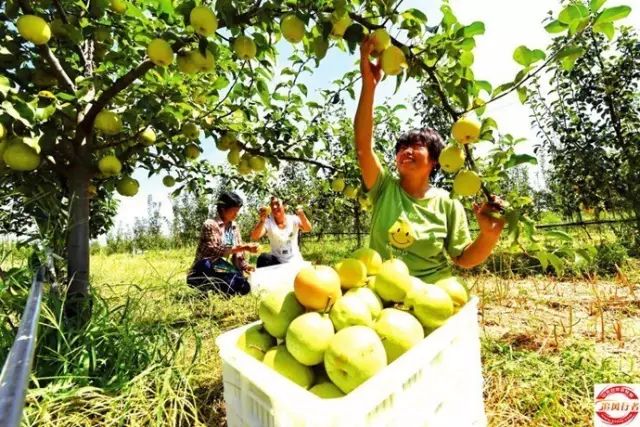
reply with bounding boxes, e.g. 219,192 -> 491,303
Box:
3,240 -> 640,426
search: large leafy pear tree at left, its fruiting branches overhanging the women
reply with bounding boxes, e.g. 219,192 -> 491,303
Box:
0,0 -> 628,308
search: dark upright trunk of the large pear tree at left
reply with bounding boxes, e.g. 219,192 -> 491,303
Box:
67,165 -> 90,299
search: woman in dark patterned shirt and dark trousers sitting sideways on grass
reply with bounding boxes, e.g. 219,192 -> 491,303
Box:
187,192 -> 258,295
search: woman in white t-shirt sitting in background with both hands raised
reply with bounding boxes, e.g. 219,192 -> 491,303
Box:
251,196 -> 311,268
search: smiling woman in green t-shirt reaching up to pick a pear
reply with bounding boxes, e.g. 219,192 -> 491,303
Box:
354,39 -> 504,283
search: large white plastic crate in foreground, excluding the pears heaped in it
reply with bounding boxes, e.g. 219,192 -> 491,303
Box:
216,298 -> 486,427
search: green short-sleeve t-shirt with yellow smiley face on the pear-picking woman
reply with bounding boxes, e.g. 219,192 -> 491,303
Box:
369,171 -> 471,283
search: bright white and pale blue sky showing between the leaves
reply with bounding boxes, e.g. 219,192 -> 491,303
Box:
115,0 -> 640,236
